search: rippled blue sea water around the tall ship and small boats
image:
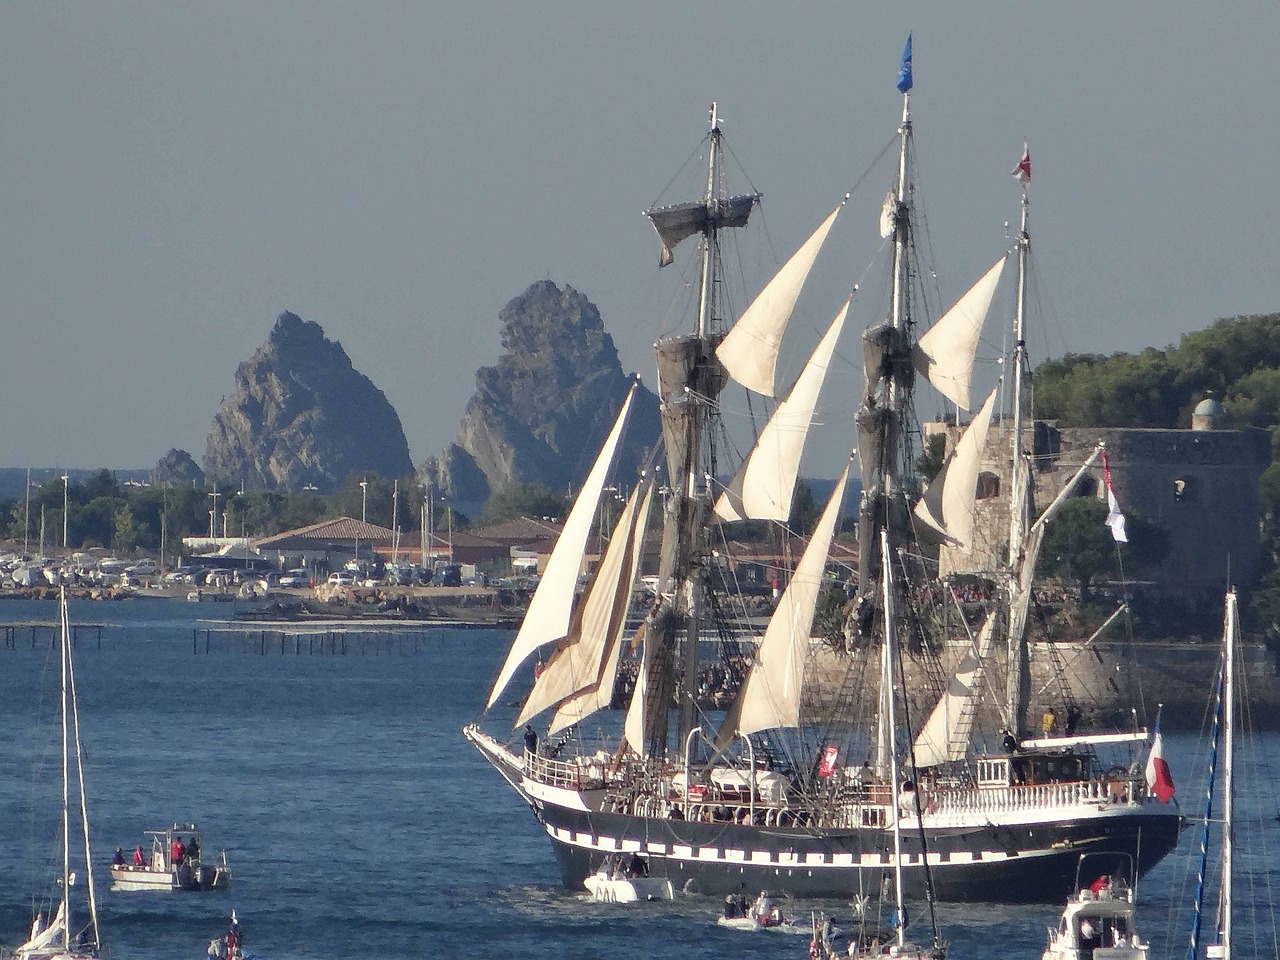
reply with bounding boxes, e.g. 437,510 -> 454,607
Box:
0,599 -> 1280,960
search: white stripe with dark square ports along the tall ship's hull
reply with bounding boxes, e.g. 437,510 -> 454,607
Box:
547,824 -> 1062,870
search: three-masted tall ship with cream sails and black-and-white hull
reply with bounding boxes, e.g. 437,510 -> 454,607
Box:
463,40 -> 1180,902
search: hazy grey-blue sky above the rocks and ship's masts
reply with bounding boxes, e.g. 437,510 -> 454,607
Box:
0,0 -> 1280,474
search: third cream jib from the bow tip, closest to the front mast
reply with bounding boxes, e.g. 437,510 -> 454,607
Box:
543,484 -> 653,736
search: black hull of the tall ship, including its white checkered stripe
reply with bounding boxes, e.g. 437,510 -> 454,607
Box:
532,801 -> 1181,904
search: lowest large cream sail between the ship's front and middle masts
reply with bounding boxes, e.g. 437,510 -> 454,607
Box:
721,465 -> 849,742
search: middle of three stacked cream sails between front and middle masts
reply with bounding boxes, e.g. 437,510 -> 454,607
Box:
714,297 -> 852,521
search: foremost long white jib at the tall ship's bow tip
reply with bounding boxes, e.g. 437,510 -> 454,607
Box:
485,384 -> 636,709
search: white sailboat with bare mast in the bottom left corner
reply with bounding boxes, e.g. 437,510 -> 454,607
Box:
13,588 -> 102,960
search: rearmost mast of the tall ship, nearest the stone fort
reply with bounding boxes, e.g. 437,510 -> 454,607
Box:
1005,179 -> 1032,736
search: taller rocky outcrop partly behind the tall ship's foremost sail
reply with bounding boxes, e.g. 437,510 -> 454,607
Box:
422,280 -> 659,503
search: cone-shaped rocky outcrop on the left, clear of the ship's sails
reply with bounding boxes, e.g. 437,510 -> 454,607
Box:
205,314 -> 413,493
